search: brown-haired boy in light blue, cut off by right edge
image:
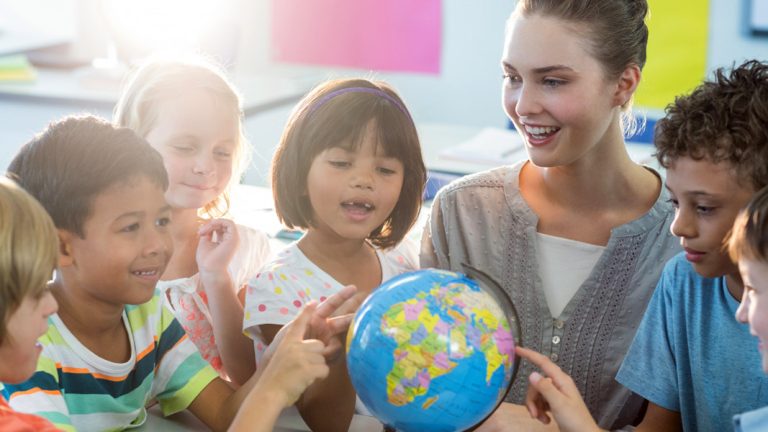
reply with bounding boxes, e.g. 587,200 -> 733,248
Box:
728,188 -> 768,432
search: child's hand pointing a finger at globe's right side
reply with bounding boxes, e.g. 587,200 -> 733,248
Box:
515,347 -> 601,432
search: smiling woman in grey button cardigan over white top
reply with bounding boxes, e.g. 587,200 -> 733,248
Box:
421,0 -> 677,430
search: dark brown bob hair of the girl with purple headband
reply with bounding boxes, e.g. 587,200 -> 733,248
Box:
272,79 -> 426,248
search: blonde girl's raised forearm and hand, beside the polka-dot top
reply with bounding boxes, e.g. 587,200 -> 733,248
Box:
196,219 -> 256,385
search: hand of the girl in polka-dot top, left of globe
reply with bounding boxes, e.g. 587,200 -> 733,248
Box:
305,285 -> 363,361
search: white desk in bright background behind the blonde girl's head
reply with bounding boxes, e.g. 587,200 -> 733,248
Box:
0,69 -> 313,181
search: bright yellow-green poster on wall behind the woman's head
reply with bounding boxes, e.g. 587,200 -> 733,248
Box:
635,0 -> 709,109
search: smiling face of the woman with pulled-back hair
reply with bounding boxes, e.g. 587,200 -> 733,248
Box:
502,15 -> 619,167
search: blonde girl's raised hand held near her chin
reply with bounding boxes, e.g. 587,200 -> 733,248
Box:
195,219 -> 240,276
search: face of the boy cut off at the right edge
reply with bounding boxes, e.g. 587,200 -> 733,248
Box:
736,259 -> 768,373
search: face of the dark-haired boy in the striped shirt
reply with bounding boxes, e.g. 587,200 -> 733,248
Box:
62,176 -> 173,307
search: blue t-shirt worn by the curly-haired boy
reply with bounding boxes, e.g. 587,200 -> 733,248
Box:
616,254 -> 768,432
